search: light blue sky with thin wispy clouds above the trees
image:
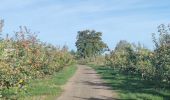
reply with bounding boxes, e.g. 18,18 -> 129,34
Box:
0,0 -> 170,50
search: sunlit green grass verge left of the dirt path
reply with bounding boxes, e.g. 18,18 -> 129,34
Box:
2,65 -> 76,100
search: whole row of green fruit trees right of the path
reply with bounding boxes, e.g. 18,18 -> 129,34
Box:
105,25 -> 170,86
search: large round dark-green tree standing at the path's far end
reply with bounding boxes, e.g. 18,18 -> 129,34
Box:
76,30 -> 107,58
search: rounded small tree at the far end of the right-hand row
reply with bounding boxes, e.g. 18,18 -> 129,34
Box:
110,40 -> 136,73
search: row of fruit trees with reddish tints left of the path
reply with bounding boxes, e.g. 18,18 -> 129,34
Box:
0,27 -> 74,97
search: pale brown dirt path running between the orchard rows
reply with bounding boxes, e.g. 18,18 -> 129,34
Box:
57,65 -> 115,100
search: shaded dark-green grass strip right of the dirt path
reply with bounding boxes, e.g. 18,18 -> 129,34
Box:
90,65 -> 170,100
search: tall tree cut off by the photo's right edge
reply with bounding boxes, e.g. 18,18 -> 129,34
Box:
153,24 -> 170,82
